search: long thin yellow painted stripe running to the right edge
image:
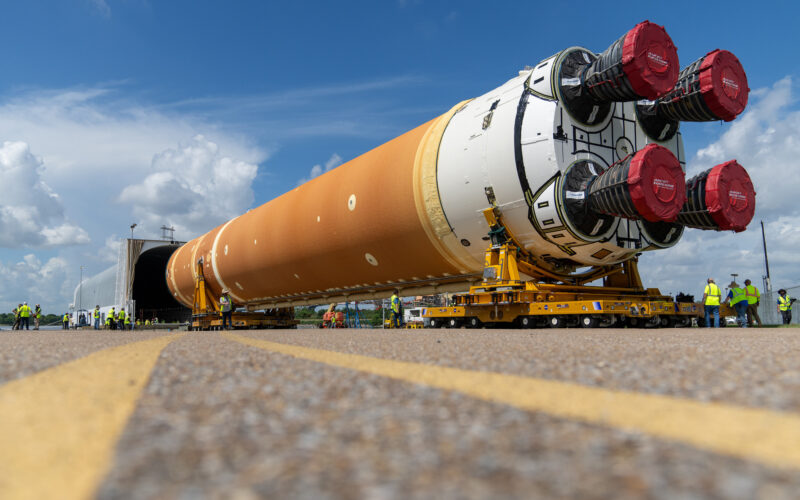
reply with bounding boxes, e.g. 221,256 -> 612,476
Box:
223,333 -> 800,468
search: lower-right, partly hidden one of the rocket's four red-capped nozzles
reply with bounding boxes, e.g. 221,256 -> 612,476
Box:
678,160 -> 756,233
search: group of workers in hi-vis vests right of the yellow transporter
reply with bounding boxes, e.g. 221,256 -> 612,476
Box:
702,278 -> 796,328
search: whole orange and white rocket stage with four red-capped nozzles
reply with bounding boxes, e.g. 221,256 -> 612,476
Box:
166,21 -> 755,309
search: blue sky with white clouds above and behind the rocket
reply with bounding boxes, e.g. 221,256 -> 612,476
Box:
0,0 -> 800,310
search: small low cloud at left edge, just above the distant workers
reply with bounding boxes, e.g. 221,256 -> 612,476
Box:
0,254 -> 71,314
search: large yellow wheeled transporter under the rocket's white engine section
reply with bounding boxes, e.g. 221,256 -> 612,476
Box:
422,207 -> 703,328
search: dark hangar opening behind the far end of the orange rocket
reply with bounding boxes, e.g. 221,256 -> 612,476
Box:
131,245 -> 192,323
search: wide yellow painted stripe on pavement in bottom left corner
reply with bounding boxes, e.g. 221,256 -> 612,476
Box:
0,335 -> 180,500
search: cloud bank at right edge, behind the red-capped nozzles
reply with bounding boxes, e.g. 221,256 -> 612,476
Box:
641,78 -> 800,298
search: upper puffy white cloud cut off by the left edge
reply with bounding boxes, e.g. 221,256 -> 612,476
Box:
0,141 -> 89,248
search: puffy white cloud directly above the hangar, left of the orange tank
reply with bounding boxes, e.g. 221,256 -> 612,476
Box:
119,135 -> 258,234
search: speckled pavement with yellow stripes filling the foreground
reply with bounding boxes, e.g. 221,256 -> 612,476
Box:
0,328 -> 800,500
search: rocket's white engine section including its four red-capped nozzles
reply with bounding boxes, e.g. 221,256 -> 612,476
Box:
437,21 -> 755,274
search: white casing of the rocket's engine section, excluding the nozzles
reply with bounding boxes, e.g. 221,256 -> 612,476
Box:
437,48 -> 685,265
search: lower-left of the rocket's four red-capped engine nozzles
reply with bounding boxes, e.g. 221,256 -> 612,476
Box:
587,144 -> 686,222
